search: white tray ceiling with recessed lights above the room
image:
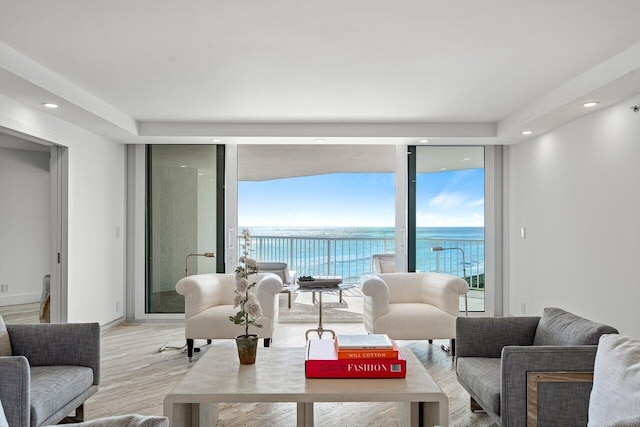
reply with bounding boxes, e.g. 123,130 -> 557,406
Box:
0,0 -> 640,144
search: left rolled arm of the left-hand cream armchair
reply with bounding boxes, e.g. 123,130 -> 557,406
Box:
176,274 -> 228,319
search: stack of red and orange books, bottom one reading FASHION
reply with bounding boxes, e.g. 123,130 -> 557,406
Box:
305,334 -> 407,378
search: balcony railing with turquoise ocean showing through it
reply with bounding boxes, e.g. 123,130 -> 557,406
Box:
242,236 -> 484,289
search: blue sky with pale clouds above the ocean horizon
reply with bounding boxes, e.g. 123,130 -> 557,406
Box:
238,169 -> 484,227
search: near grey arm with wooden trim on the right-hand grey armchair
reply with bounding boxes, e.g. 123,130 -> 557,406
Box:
500,345 -> 597,426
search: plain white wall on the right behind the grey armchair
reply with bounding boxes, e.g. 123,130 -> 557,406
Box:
508,100 -> 640,338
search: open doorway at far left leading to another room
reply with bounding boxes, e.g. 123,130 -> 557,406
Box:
0,129 -> 67,323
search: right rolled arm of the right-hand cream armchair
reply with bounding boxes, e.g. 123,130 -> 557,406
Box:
422,273 -> 469,317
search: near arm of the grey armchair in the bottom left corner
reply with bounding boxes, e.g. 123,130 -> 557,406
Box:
0,356 -> 31,426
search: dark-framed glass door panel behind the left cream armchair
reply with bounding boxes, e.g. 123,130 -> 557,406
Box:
145,145 -> 224,313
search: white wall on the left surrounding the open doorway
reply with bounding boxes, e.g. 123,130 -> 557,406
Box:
0,95 -> 126,324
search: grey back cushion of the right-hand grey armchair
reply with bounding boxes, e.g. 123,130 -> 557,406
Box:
533,307 -> 618,345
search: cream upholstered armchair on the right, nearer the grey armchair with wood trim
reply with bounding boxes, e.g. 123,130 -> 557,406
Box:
360,273 -> 469,354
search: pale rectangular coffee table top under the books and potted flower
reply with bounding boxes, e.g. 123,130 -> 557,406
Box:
165,343 -> 447,402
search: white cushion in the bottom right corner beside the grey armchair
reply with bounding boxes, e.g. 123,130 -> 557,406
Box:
588,335 -> 640,426
